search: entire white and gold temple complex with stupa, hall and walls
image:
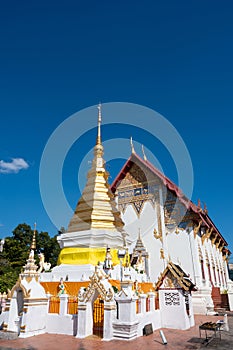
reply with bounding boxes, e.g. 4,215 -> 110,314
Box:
0,106 -> 233,340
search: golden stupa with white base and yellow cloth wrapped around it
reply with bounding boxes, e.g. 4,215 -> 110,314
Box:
58,105 -> 125,265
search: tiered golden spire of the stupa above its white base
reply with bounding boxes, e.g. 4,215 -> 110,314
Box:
67,105 -> 124,232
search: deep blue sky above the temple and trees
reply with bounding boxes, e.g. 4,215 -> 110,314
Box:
0,0 -> 233,258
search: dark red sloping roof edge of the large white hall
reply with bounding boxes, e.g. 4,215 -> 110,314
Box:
111,152 -> 228,246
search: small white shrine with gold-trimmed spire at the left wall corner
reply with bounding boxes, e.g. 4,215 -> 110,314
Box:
0,227 -> 48,338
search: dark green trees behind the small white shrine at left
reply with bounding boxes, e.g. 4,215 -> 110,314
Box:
0,223 -> 60,292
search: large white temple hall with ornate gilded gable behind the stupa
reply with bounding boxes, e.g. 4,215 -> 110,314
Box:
111,139 -> 230,313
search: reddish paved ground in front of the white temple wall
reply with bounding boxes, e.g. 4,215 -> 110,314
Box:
0,314 -> 233,350
